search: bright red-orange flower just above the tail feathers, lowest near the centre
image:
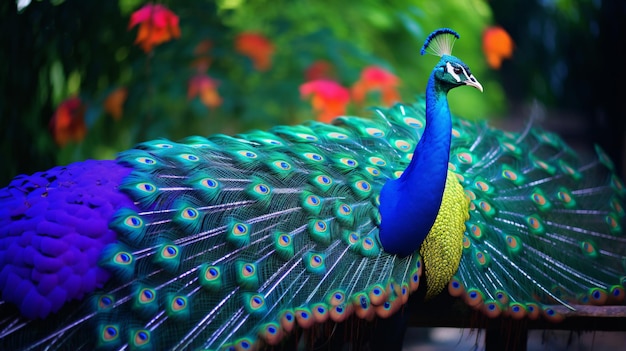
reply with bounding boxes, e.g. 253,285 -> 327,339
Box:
300,79 -> 350,123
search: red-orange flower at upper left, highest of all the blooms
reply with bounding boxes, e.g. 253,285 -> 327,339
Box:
128,4 -> 180,53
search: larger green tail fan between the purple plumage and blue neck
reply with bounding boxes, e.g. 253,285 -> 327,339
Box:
0,106 -> 424,350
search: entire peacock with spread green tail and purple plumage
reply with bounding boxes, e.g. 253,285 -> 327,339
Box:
0,28 -> 626,350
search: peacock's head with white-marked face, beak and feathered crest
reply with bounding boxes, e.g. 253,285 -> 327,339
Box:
421,28 -> 483,93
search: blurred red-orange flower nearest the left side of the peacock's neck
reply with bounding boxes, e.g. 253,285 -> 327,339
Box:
352,66 -> 400,105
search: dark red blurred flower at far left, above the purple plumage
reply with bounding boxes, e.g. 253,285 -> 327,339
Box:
50,97 -> 87,146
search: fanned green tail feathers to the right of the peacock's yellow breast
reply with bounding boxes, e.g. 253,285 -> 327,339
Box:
449,117 -> 626,320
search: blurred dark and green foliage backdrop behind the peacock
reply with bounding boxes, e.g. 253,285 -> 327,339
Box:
0,0 -> 626,184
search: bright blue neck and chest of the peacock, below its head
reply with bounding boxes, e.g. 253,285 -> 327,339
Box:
379,72 -> 452,256
